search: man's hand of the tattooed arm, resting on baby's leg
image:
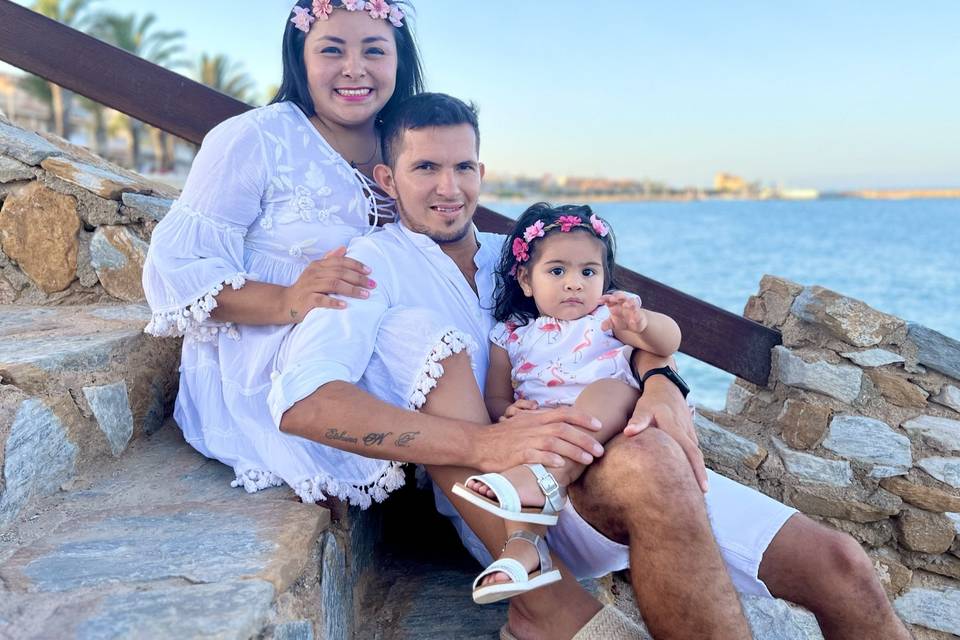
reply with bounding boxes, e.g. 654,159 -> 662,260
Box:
471,407 -> 603,472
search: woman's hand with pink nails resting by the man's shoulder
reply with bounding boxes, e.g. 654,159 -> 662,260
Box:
283,247 -> 377,324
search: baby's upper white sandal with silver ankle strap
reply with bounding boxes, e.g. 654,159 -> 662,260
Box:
453,464 -> 567,526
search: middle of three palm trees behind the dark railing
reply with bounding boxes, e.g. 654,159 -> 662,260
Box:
93,12 -> 184,170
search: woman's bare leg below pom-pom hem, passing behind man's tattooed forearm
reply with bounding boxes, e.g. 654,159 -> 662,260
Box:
421,353 -> 601,640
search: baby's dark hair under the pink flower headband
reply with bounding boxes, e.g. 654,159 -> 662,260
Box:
493,202 -> 618,326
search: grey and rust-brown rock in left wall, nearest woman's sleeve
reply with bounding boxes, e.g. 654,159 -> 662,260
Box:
90,226 -> 149,302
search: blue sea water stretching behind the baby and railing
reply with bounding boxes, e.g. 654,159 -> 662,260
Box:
486,199 -> 960,409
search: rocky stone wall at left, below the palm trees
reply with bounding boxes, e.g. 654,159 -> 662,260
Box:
0,118 -> 177,305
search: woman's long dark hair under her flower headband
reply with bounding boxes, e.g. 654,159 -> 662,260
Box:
270,0 -> 423,123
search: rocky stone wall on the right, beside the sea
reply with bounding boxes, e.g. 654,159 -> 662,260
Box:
697,276 -> 960,638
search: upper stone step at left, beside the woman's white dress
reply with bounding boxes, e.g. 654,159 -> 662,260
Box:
0,304 -> 180,531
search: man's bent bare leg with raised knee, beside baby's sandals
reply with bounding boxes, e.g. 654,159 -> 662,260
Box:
569,429 -> 750,640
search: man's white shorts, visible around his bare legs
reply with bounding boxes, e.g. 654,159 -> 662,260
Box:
434,470 -> 797,597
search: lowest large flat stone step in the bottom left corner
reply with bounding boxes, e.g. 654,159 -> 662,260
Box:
0,424 -> 330,640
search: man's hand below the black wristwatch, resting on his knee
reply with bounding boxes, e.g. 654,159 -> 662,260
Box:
623,376 -> 708,493
